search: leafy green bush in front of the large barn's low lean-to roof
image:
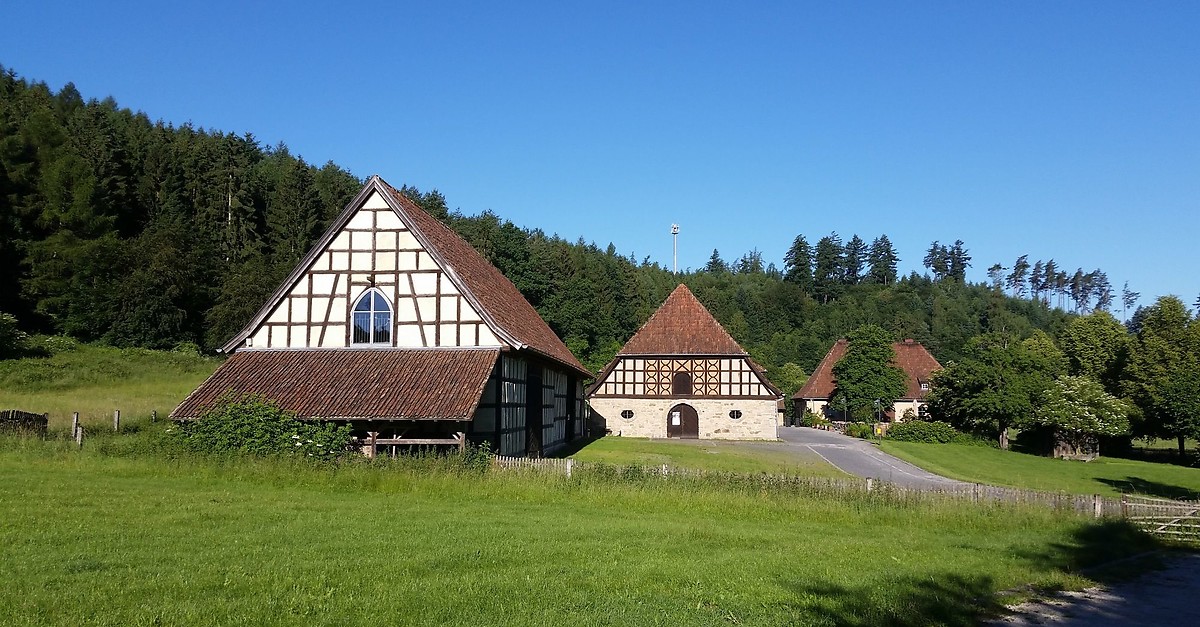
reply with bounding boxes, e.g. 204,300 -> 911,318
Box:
173,394 -> 350,460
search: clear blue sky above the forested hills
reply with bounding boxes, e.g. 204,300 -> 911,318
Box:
0,0 -> 1200,304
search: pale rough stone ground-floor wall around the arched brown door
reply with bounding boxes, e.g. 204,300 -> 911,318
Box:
588,398 -> 779,440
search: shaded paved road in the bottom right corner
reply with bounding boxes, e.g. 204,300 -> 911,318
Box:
985,554 -> 1200,627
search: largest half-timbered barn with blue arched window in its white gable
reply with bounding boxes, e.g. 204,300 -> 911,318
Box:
172,177 -> 590,455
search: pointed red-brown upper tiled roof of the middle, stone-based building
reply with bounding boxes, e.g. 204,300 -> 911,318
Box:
617,283 -> 746,356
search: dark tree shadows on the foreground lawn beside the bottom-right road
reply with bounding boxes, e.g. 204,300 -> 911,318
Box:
780,520 -> 1162,627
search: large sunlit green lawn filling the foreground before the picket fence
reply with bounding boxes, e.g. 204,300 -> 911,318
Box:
0,431 -> 1153,626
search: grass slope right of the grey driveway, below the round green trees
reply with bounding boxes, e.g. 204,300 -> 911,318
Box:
882,440 -> 1200,498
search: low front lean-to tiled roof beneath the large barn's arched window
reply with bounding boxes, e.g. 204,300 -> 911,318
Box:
172,348 -> 500,420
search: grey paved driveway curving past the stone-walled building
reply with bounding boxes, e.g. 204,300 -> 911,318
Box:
776,426 -> 960,488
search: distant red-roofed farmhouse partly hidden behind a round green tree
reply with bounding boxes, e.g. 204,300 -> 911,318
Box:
792,339 -> 942,422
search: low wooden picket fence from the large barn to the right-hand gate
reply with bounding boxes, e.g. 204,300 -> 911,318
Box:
493,456 -> 1200,526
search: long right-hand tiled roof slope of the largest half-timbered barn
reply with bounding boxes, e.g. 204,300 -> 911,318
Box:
376,179 -> 592,377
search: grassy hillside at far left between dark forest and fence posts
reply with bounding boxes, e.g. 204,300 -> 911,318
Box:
0,338 -> 218,431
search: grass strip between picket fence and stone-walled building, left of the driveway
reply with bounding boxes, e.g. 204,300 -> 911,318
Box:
571,436 -> 847,477
